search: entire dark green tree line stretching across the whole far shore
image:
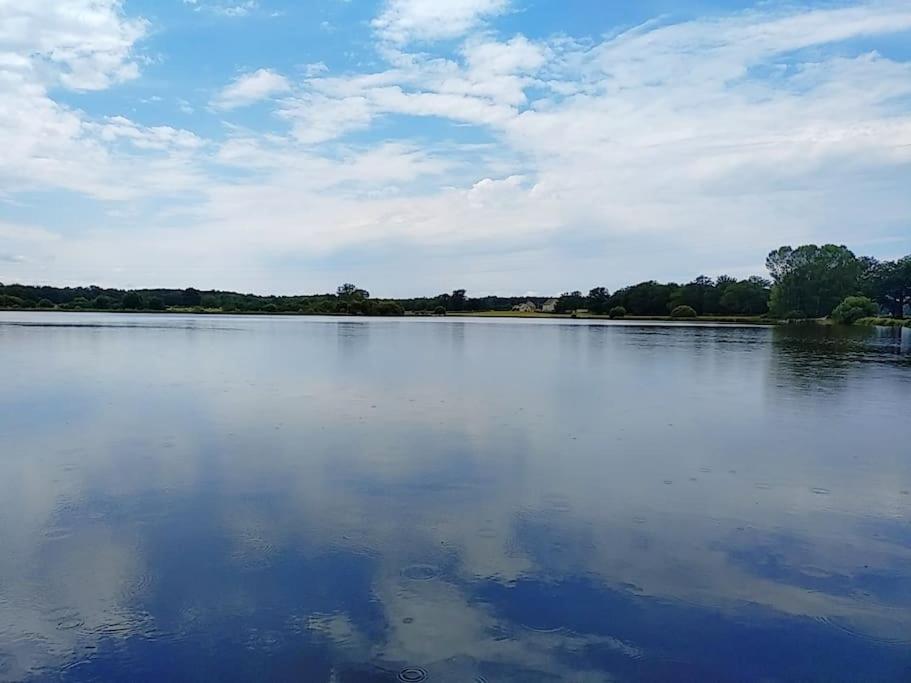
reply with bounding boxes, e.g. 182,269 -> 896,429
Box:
0,244 -> 911,320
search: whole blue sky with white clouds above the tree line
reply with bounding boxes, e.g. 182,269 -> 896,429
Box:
0,0 -> 911,296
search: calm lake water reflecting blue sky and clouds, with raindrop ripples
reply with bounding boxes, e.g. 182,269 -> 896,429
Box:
0,314 -> 911,683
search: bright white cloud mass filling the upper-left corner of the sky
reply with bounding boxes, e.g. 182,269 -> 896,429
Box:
0,0 -> 208,199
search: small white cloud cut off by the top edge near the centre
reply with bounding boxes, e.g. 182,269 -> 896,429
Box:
373,0 -> 509,44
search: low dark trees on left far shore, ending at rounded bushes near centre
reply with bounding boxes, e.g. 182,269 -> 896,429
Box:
0,283 -> 405,315
